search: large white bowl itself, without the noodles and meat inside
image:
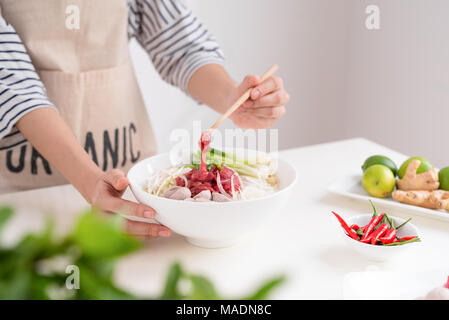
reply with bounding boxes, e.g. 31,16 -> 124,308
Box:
128,154 -> 296,248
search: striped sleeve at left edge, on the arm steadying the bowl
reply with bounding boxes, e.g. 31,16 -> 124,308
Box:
0,15 -> 54,140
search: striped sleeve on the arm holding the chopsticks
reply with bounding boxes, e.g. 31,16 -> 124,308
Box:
128,0 -> 223,93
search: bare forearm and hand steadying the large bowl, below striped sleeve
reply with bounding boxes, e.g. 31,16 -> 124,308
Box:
17,108 -> 170,239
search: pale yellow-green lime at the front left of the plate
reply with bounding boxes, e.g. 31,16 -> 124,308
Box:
362,164 -> 396,198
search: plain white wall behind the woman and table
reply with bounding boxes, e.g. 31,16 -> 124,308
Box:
131,0 -> 449,167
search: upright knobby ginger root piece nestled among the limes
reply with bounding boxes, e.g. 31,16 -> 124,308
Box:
397,160 -> 440,191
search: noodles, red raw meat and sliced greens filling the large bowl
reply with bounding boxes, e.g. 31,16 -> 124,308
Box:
145,145 -> 278,202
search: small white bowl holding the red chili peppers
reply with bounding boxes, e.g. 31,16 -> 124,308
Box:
342,213 -> 422,261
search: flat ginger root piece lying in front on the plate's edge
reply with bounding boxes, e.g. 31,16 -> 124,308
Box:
392,190 -> 449,211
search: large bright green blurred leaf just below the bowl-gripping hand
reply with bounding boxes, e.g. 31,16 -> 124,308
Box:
73,211 -> 141,259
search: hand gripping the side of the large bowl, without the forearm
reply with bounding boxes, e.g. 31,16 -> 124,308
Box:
90,169 -> 170,240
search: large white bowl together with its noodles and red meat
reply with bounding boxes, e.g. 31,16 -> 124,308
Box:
128,149 -> 297,248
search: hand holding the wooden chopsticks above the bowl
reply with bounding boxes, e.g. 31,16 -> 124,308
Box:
230,76 -> 290,129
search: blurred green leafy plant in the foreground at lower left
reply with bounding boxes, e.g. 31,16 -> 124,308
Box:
0,208 -> 284,300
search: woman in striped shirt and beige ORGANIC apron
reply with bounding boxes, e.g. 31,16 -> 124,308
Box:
0,0 -> 289,238
